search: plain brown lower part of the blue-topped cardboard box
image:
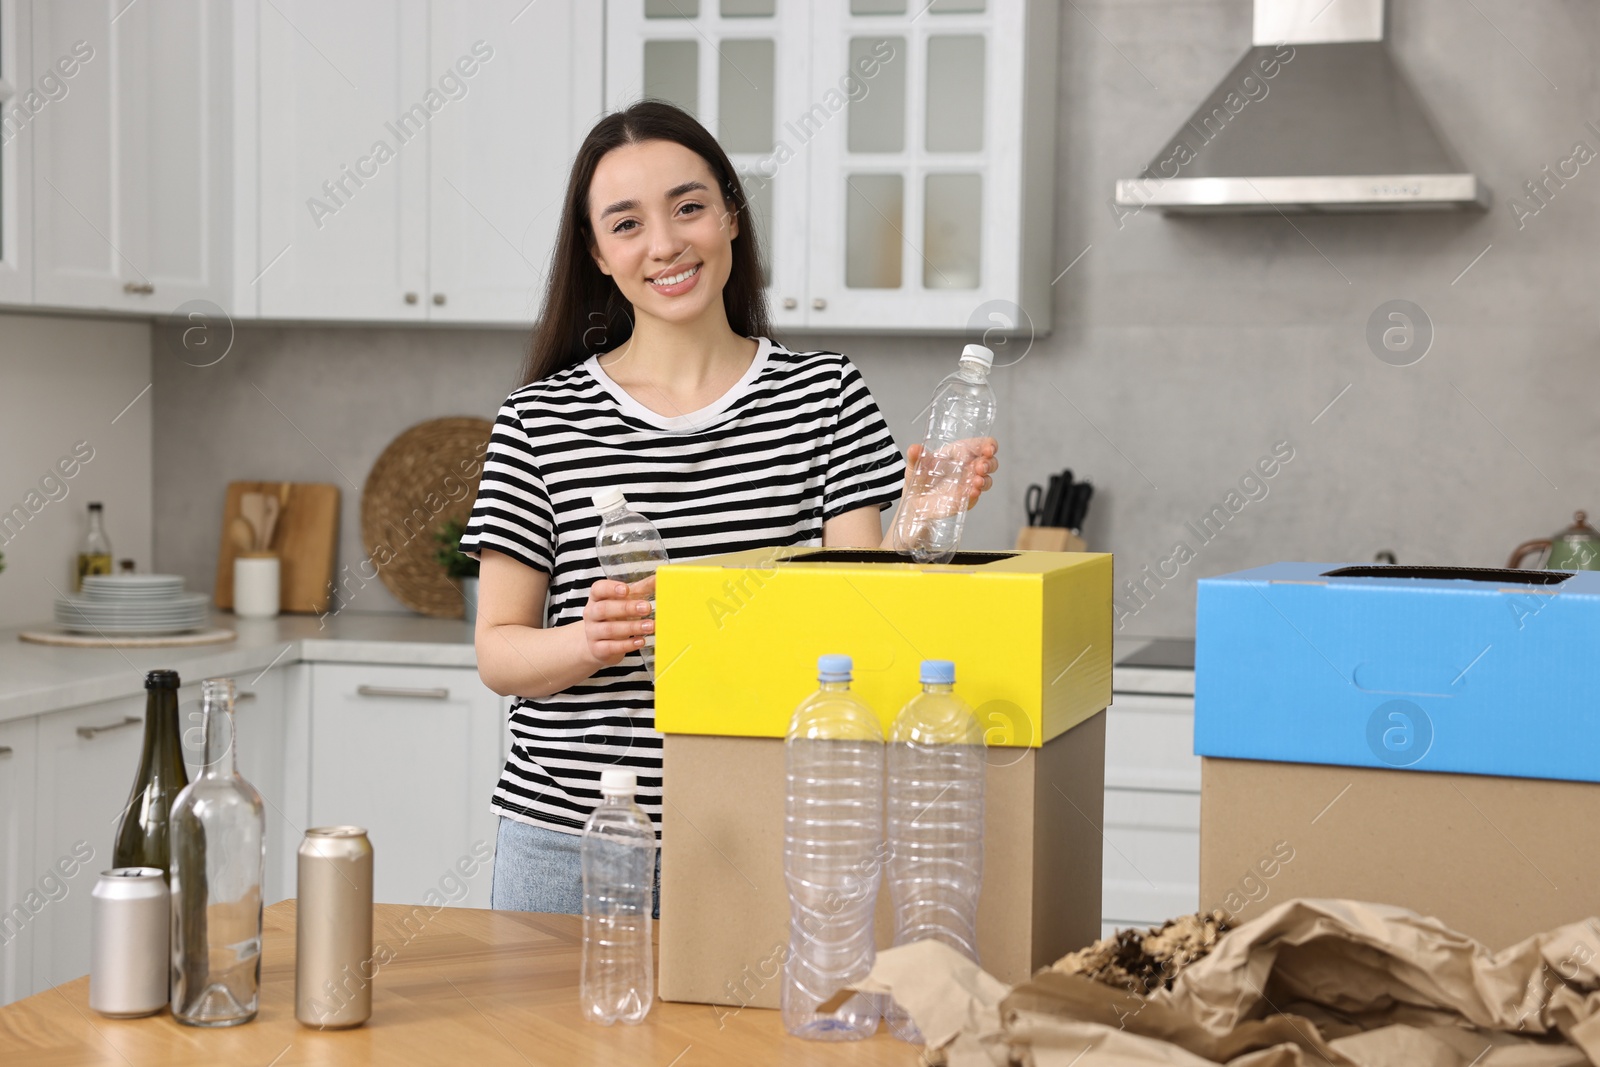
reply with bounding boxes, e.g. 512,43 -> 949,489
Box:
1200,757 -> 1600,949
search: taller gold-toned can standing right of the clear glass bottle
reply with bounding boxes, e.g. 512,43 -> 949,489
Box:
294,825 -> 378,1030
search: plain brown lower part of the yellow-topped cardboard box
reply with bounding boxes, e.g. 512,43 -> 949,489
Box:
659,712 -> 1106,1008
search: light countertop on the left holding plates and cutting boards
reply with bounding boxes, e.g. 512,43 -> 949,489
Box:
0,611 -> 477,721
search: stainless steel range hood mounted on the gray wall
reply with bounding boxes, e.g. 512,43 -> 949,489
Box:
1115,0 -> 1490,219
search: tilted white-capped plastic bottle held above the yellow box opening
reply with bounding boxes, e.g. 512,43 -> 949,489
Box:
893,344 -> 995,563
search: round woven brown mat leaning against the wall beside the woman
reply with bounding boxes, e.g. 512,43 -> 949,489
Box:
352,418 -> 494,619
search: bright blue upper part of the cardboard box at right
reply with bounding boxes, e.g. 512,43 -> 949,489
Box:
1195,563 -> 1600,782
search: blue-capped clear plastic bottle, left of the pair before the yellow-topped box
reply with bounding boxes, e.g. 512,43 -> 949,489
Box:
782,656 -> 883,1041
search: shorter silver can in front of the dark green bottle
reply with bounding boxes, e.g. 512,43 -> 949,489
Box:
90,867 -> 173,1019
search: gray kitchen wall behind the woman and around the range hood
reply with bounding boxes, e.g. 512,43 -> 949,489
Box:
155,0 -> 1600,635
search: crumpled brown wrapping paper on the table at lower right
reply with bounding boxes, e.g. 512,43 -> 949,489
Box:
859,899 -> 1600,1067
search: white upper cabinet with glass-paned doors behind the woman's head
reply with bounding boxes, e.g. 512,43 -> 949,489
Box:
606,0 -> 1058,333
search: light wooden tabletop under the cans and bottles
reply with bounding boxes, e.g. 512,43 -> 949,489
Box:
0,901 -> 920,1067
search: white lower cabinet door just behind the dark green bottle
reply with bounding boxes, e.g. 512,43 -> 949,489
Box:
34,696 -> 144,989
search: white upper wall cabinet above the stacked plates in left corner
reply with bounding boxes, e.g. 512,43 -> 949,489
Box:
30,0 -> 232,314
